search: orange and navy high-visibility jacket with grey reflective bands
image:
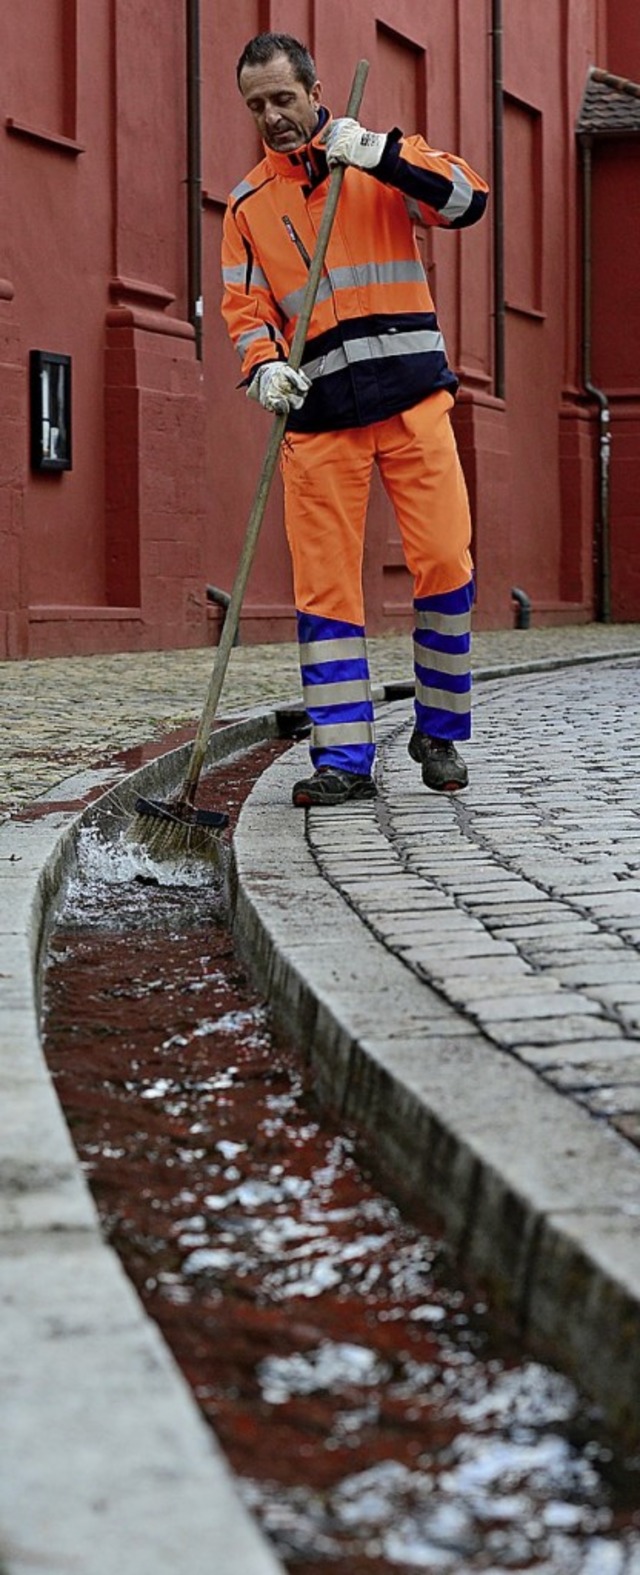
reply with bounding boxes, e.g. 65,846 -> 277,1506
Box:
222,110 -> 487,432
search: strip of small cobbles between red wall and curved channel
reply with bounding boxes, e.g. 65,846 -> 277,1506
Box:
0,624 -> 640,817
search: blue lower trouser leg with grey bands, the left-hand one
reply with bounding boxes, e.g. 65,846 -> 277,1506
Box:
298,613 -> 375,776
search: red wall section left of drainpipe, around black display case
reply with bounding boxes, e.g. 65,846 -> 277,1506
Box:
0,0 -> 207,655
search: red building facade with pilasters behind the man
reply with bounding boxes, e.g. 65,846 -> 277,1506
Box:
0,0 -> 640,658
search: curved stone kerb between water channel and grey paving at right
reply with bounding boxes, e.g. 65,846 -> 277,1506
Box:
232,730 -> 640,1444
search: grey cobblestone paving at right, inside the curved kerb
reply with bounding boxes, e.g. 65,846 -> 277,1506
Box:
362,658 -> 640,1145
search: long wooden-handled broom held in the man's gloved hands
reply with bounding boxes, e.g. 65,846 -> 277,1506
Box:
128,60 -> 369,863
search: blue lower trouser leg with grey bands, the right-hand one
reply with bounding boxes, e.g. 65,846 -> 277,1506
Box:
413,580 -> 473,740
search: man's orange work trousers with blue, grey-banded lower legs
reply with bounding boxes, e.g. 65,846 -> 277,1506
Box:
282,392 -> 473,772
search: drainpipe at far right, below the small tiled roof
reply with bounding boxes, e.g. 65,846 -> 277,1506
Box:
582,137 -> 612,624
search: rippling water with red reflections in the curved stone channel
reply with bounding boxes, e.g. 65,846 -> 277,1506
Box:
40,750 -> 640,1575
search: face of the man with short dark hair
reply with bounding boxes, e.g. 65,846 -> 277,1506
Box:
240,55 -> 322,153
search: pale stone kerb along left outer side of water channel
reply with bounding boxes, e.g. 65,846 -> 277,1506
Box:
0,710 -> 284,1575
